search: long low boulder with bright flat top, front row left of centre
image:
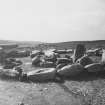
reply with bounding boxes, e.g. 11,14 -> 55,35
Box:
27,68 -> 56,81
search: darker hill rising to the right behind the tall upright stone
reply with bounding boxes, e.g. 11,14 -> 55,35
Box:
37,40 -> 105,49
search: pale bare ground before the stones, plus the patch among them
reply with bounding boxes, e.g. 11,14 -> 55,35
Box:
0,58 -> 105,105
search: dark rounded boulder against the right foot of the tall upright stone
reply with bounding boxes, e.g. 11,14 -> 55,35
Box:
76,56 -> 93,66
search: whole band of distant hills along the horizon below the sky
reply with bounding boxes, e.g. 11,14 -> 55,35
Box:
0,40 -> 105,49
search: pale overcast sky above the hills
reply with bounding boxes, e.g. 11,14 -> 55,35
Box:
0,0 -> 105,42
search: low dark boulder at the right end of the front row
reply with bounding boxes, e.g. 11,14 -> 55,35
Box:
84,63 -> 104,72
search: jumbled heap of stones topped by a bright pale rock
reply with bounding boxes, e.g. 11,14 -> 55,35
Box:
30,51 -> 56,67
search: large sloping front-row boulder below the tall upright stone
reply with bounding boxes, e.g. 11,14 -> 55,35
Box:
57,64 -> 84,77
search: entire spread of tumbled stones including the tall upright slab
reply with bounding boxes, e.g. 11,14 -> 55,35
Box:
1,44 -> 105,81
